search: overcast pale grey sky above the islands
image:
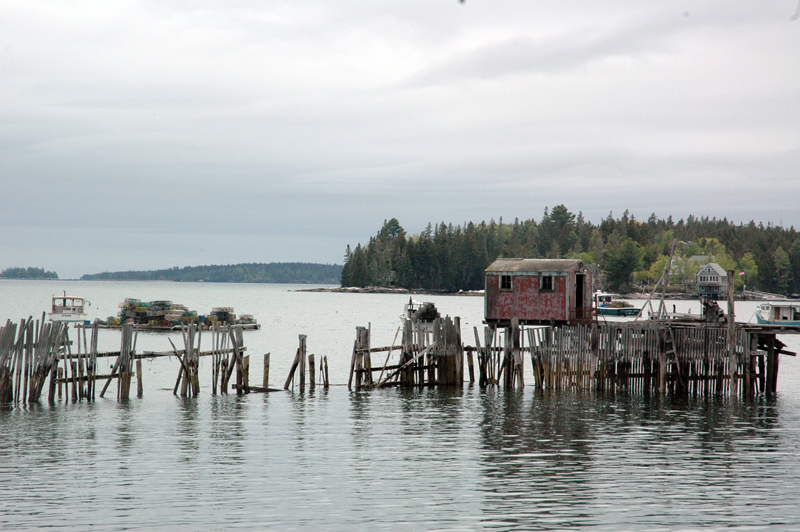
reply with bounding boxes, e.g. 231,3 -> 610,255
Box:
0,0 -> 800,278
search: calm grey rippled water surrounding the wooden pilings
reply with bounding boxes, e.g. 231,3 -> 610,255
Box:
0,281 -> 800,530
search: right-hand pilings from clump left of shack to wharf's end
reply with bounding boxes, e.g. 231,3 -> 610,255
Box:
348,318 -> 792,397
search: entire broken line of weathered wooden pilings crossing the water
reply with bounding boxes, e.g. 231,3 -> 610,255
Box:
0,316 -> 792,404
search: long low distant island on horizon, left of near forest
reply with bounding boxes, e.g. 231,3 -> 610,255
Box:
81,262 -> 342,284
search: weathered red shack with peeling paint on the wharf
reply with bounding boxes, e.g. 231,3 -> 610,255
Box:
484,259 -> 592,326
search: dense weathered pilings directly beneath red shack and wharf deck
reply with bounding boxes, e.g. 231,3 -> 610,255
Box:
475,320 -> 792,397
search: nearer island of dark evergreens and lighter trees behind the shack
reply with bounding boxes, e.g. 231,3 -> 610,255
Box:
341,205 -> 800,294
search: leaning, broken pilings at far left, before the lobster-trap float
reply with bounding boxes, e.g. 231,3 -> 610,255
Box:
0,315 -> 258,404
